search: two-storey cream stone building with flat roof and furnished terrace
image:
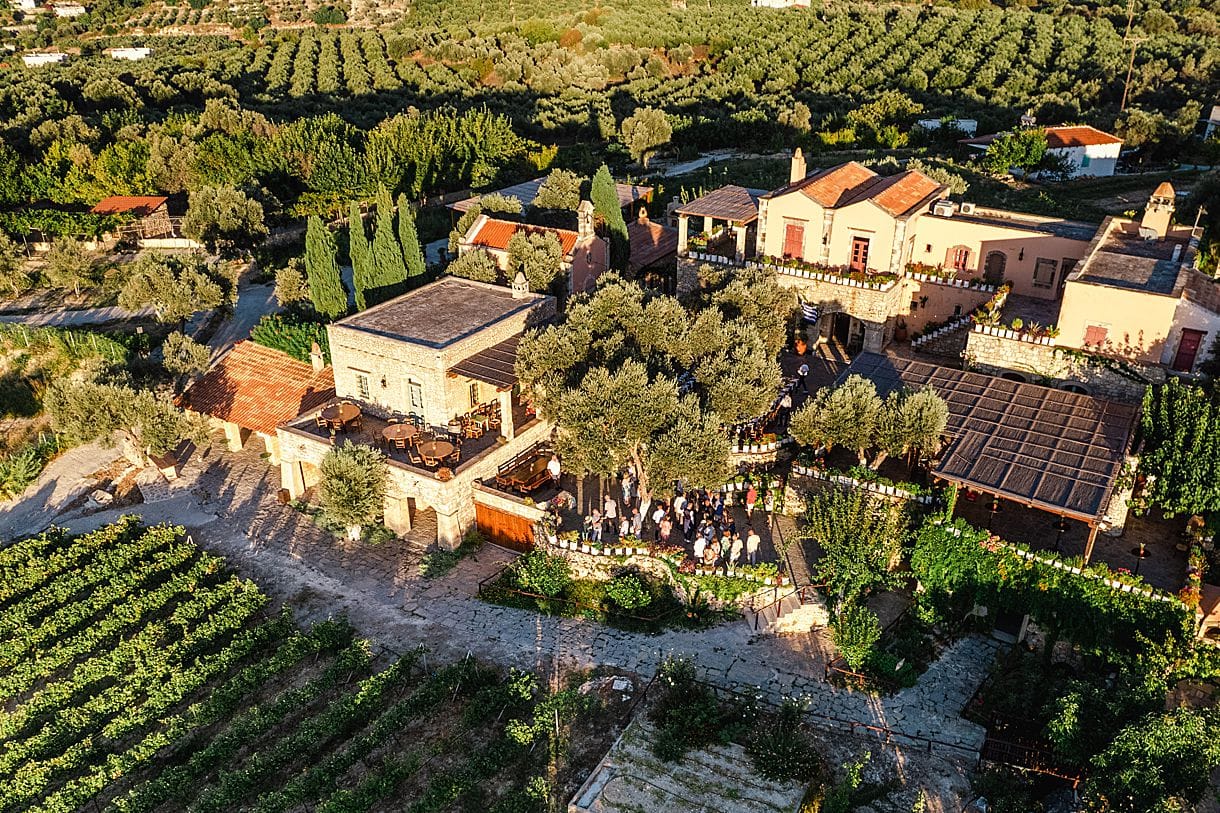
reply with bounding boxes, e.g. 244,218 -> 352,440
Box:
278,277 -> 555,548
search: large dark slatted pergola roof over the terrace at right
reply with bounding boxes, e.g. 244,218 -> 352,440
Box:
839,353 -> 1136,562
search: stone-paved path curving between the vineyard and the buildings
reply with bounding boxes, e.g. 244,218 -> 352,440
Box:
16,441 -> 996,756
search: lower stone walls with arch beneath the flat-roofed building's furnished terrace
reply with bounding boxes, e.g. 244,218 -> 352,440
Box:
279,420 -> 551,549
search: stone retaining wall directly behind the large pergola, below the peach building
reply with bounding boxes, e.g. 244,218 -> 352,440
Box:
966,331 -> 1165,403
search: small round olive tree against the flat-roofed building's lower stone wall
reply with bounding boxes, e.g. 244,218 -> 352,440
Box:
317,441 -> 388,540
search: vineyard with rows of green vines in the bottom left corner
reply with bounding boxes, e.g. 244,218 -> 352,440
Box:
0,518 -> 610,813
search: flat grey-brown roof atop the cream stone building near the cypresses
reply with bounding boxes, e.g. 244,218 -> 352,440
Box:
334,276 -> 547,348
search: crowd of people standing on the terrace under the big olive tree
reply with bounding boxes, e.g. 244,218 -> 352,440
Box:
581,468 -> 763,570
